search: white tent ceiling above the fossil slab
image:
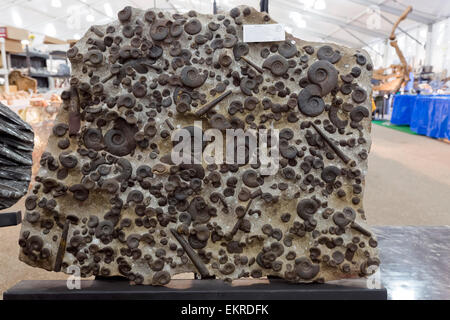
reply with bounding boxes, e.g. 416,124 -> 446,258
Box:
0,0 -> 450,47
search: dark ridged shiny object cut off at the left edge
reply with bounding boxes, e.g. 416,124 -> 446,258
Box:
0,103 -> 34,210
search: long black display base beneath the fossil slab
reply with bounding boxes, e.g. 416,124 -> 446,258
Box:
3,279 -> 387,300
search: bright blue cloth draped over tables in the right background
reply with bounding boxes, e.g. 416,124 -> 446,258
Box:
391,95 -> 450,140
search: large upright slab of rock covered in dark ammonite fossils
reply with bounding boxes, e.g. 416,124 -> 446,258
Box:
19,6 -> 379,285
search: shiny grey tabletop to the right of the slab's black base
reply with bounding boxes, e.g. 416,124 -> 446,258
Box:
373,226 -> 450,300
